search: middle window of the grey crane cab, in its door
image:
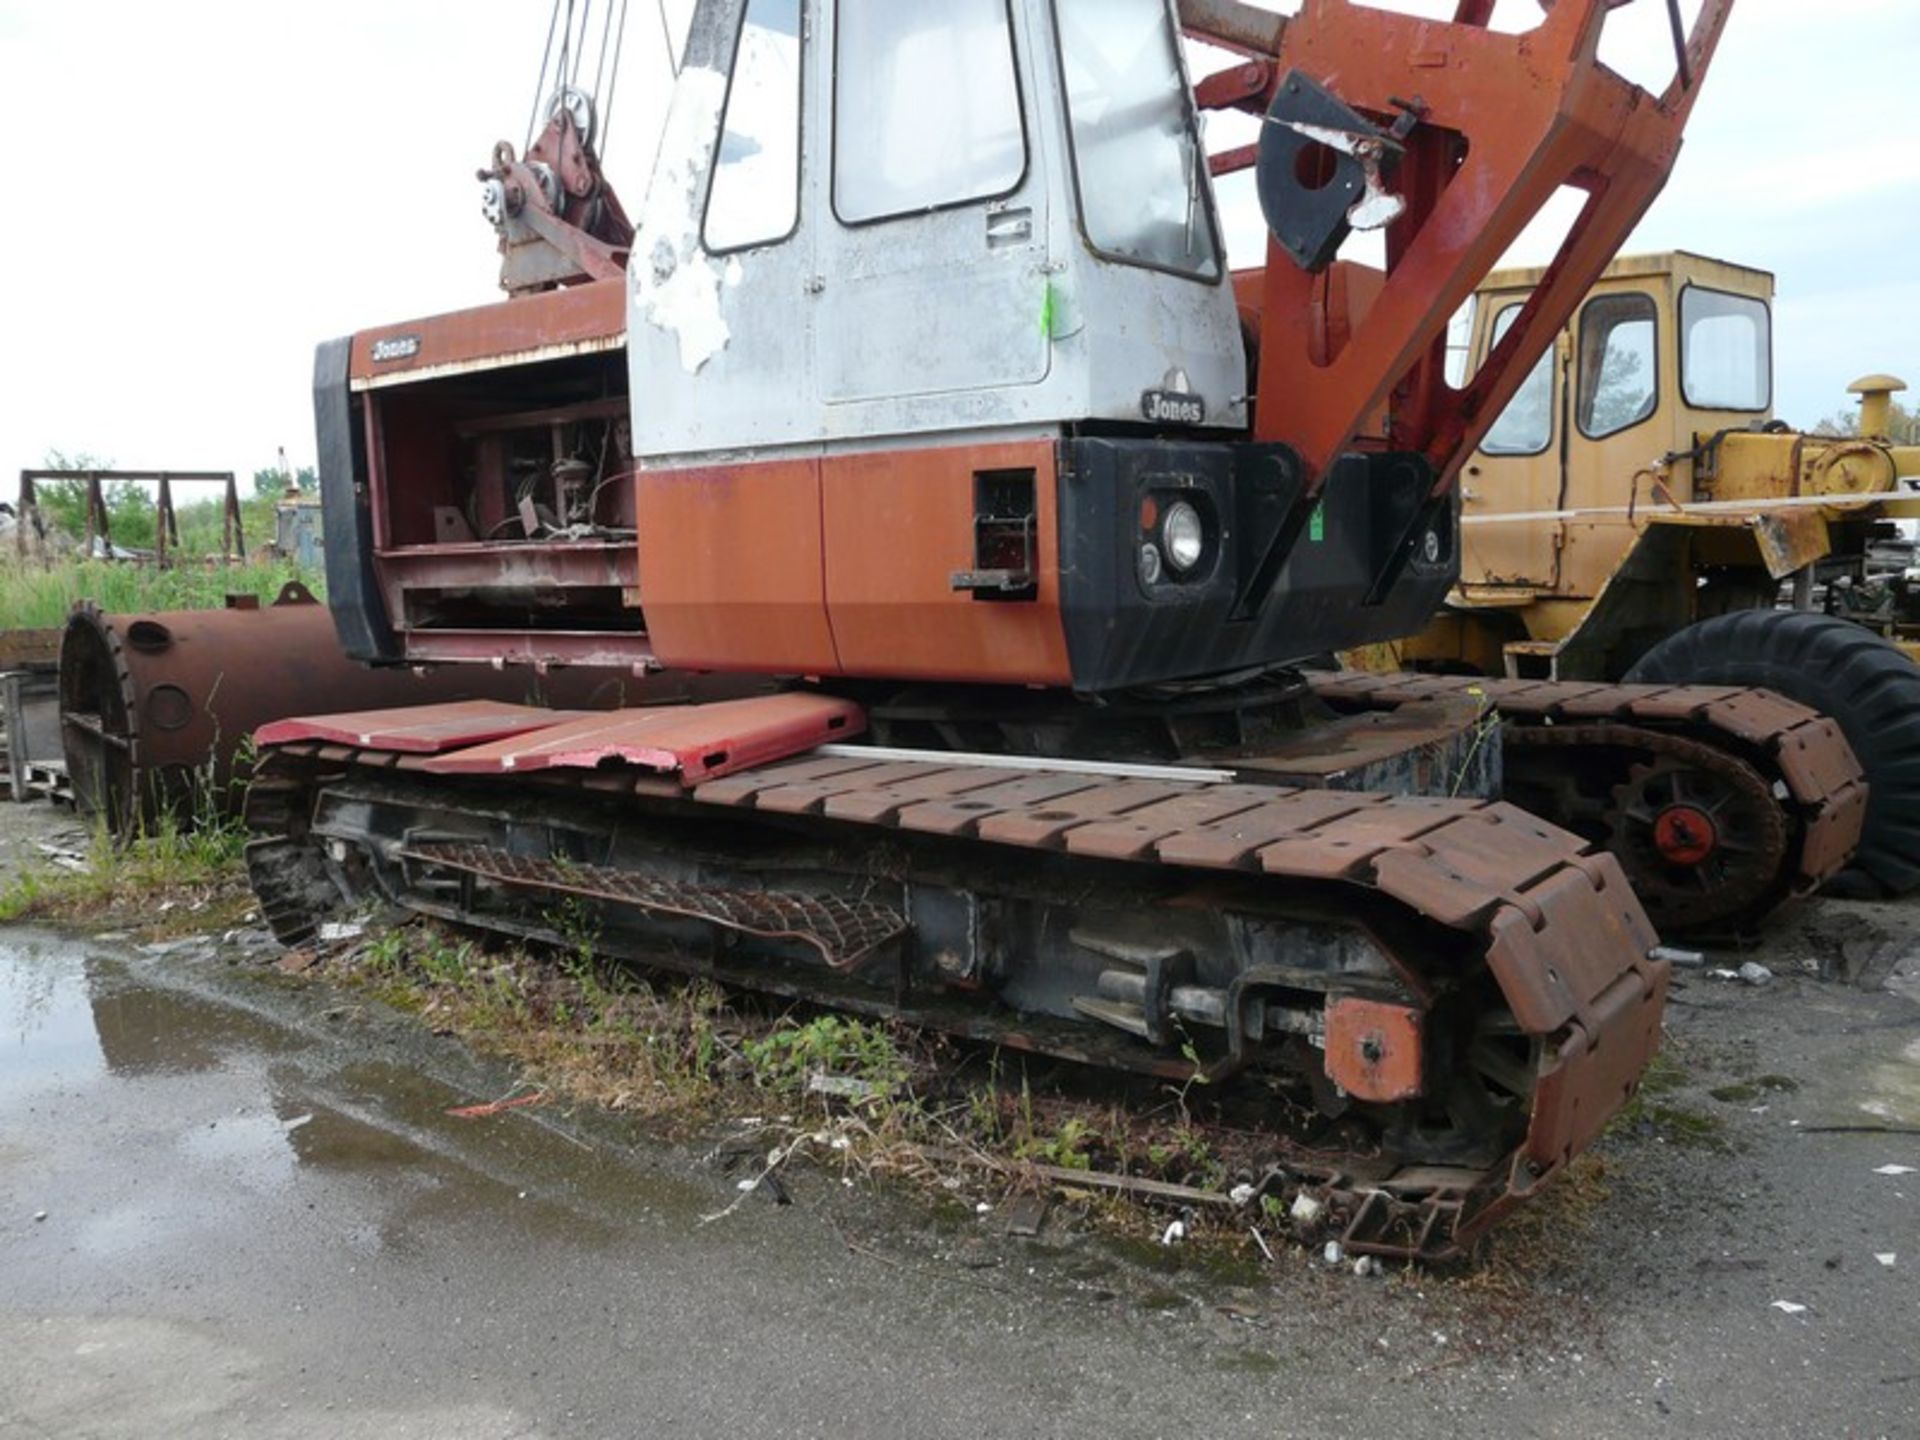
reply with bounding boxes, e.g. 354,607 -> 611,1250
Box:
833,0 -> 1027,225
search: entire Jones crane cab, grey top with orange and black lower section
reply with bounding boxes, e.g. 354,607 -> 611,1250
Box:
628,0 -> 1452,691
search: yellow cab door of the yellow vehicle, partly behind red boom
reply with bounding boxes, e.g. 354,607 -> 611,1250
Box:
1459,294 -> 1569,599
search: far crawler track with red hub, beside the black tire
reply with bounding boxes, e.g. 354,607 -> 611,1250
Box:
1313,670 -> 1866,939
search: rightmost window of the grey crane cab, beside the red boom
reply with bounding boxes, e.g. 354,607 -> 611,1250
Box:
1054,0 -> 1221,280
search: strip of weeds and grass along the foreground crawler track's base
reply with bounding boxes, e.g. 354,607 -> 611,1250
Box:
311,917 -> 1252,1213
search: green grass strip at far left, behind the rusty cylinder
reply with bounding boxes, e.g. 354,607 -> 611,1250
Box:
0,557 -> 324,630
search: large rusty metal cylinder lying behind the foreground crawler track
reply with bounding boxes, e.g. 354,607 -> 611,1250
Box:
60,586 -> 739,835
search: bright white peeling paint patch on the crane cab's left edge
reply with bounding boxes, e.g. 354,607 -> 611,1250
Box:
628,69 -> 737,374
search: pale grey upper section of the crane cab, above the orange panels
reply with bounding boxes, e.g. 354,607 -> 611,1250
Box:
628,0 -> 1246,459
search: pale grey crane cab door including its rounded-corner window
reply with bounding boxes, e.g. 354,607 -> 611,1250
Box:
812,0 -> 1050,407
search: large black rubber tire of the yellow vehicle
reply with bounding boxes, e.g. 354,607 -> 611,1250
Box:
1624,611 -> 1920,895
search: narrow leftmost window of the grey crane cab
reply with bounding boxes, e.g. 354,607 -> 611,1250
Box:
701,0 -> 801,253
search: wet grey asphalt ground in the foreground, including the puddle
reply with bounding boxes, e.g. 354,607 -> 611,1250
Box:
0,906 -> 1920,1440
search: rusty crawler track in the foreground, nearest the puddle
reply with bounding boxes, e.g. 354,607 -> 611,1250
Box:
246,741 -> 1667,1260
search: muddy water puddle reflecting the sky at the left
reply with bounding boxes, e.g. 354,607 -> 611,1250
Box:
0,929 -> 710,1256
